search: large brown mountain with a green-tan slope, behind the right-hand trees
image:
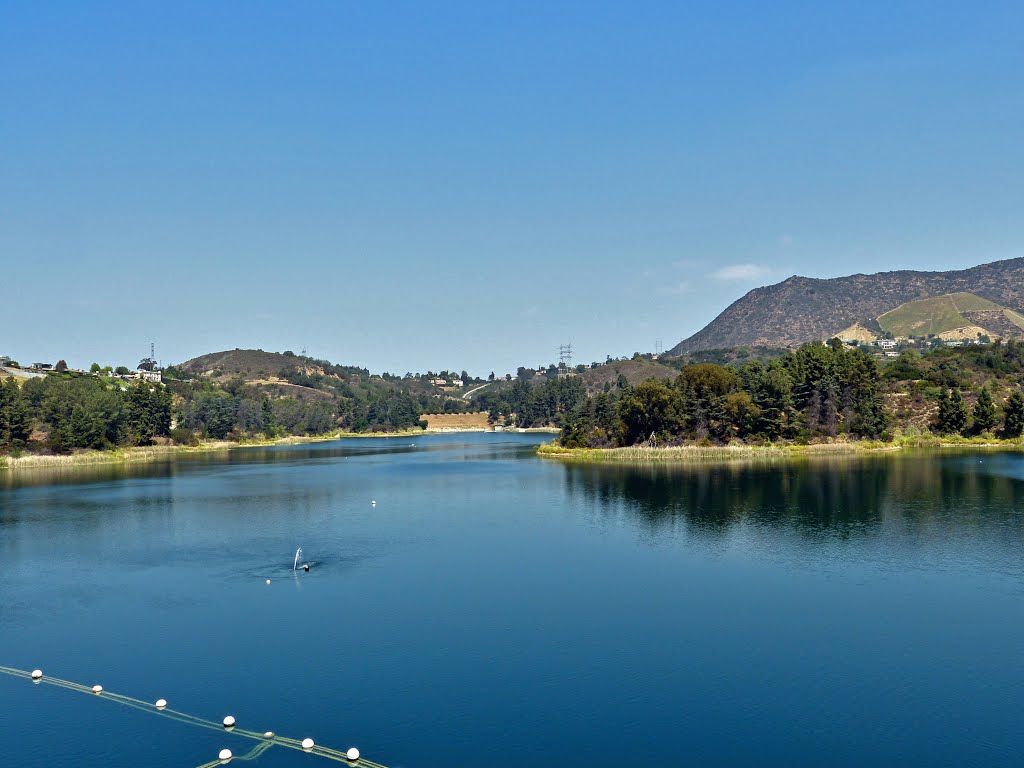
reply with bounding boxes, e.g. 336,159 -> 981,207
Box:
669,258 -> 1024,355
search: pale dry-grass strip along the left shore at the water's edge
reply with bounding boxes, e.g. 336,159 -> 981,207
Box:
0,427 -> 559,472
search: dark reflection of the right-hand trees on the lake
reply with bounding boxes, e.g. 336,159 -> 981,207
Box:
565,453 -> 1024,537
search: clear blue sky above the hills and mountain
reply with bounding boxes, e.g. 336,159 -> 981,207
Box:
0,0 -> 1024,374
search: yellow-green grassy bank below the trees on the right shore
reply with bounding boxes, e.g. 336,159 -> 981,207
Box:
537,437 -> 1024,465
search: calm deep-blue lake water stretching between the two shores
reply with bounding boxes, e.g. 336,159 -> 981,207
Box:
0,434 -> 1024,768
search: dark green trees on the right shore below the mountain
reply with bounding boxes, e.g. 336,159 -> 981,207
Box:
560,339 -> 1024,447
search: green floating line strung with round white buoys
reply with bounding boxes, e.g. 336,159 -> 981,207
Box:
0,667 -> 386,768
